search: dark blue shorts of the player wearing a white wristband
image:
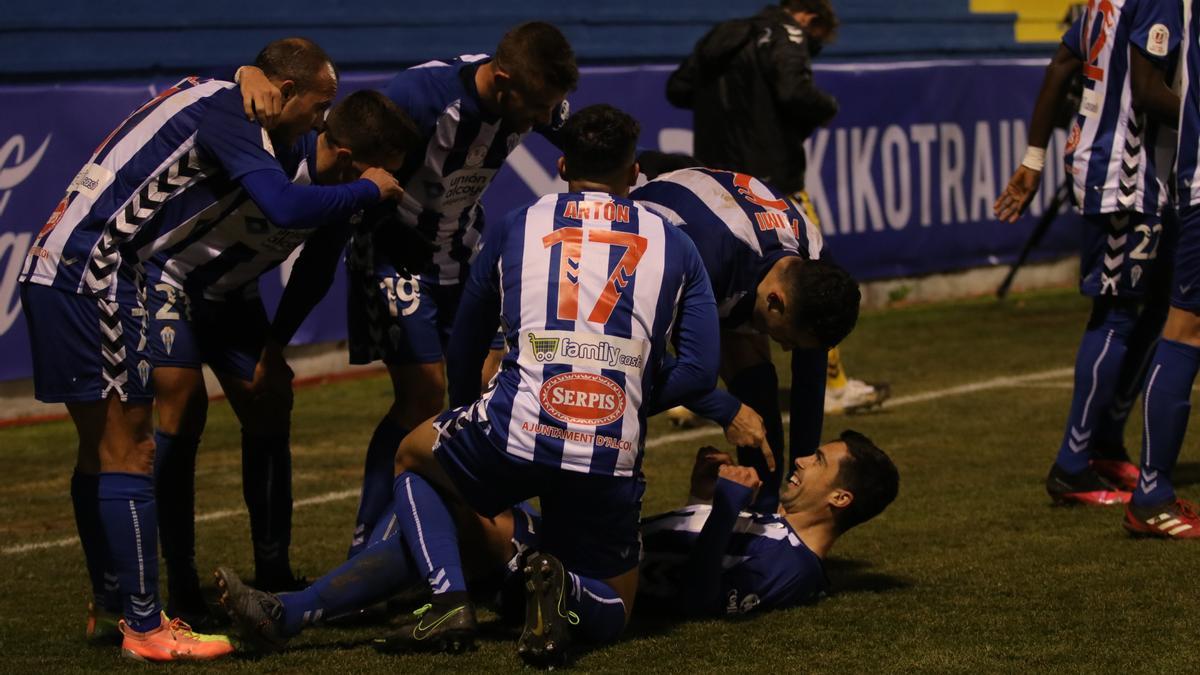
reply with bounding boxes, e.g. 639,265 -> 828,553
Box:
1079,213 -> 1177,300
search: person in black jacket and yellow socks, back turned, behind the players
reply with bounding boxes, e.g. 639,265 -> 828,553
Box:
662,0 -> 890,426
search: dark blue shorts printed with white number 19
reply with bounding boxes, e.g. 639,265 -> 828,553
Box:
346,269 -> 504,365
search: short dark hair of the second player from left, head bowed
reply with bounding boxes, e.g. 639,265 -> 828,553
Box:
325,89 -> 421,166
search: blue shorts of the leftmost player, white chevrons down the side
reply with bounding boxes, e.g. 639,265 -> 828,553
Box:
20,283 -> 154,404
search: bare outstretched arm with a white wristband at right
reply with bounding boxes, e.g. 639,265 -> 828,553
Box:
992,43 -> 1082,222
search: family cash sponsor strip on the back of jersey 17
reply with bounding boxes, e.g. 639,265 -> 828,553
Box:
521,330 -> 650,375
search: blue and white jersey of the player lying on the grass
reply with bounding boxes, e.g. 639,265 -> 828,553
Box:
637,504 -> 826,614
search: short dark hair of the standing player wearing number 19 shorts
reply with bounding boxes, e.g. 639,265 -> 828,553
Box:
496,22 -> 580,91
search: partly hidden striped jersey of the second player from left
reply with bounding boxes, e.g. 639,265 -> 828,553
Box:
128,132 -> 320,300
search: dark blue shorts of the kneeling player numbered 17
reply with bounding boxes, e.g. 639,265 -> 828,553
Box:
433,406 -> 646,579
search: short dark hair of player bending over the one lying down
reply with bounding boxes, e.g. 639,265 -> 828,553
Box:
784,259 -> 863,348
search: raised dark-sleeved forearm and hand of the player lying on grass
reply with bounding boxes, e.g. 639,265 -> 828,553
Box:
680,464 -> 762,614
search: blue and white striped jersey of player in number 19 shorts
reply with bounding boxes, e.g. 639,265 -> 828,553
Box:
349,54 -> 566,285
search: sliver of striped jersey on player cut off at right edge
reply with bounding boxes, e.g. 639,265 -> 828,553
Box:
1172,0 -> 1200,207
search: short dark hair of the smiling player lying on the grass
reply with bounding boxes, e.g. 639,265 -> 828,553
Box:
834,429 -> 900,533
